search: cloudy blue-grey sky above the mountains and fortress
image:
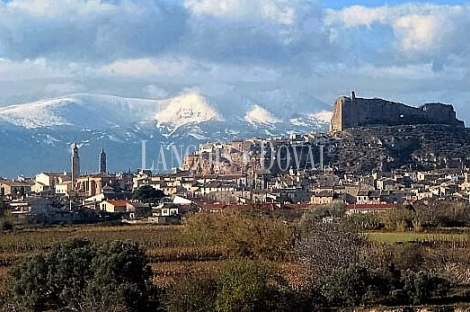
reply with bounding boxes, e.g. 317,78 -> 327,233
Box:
0,0 -> 470,122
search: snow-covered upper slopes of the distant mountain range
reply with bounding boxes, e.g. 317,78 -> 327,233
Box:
0,92 -> 331,137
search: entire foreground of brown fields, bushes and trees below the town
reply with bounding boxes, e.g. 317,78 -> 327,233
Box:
0,204 -> 470,312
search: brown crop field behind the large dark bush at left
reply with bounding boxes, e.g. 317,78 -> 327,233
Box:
0,225 -> 223,285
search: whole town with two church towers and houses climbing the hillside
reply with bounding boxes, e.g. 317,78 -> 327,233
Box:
0,134 -> 470,223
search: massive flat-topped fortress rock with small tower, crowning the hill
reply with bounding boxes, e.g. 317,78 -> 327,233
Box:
330,91 -> 465,132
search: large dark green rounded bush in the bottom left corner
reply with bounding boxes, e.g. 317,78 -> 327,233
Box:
7,239 -> 155,311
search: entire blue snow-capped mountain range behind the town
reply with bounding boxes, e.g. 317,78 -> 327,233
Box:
0,92 -> 328,176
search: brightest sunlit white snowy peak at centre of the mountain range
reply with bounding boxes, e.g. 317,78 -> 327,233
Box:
155,93 -> 222,128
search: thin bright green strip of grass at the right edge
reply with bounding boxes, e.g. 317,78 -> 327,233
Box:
365,232 -> 470,244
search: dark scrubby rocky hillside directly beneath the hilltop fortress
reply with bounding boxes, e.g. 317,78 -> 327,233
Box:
326,125 -> 470,172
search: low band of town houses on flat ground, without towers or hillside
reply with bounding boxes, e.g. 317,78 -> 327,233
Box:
0,163 -> 470,223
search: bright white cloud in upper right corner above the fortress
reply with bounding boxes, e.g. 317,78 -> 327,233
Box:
325,3 -> 470,54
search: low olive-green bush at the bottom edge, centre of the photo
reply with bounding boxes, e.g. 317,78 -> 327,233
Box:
165,260 -> 313,312
